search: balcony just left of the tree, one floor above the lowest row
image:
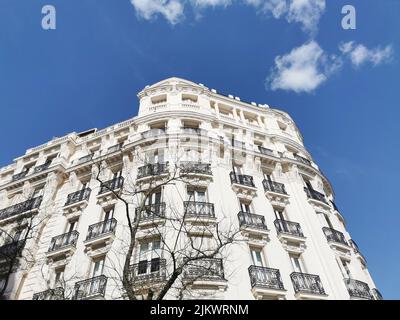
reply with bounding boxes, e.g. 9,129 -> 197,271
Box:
84,218 -> 117,255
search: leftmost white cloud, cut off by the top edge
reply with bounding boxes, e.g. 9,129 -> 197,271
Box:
131,0 -> 184,24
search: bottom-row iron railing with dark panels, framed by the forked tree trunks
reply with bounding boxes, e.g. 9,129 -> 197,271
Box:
130,258 -> 167,283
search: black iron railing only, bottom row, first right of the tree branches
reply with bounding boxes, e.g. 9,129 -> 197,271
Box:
249,266 -> 285,290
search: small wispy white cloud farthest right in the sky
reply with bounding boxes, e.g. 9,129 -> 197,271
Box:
339,41 -> 393,67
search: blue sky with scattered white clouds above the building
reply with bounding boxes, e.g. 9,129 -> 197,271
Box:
0,0 -> 400,299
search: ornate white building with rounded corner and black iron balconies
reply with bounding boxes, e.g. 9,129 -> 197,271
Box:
0,78 -> 381,300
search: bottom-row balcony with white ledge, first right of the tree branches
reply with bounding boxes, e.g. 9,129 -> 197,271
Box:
249,266 -> 286,299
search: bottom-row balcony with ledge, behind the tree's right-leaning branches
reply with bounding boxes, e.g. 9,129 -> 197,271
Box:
183,258 -> 226,290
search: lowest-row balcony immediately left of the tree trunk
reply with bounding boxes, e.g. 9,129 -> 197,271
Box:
72,275 -> 107,300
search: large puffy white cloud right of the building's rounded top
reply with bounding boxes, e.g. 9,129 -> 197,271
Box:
266,41 -> 341,93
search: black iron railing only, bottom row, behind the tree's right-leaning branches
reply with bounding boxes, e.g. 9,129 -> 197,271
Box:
183,258 -> 225,280
